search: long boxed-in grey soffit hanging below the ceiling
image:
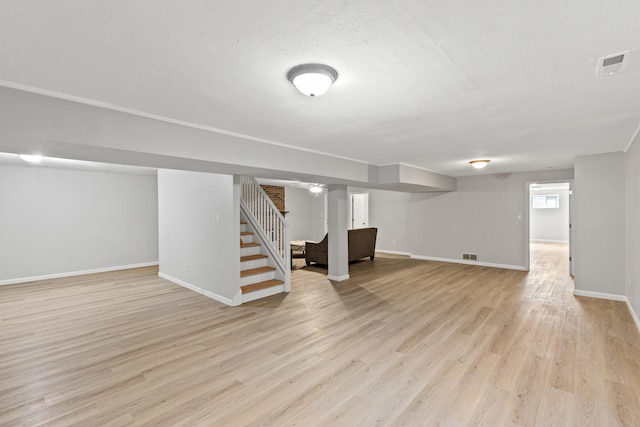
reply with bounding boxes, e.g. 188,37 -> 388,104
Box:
0,86 -> 456,192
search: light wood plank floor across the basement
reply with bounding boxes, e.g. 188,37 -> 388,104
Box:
0,244 -> 640,426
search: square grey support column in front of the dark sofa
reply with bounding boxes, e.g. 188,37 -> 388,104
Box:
327,184 -> 349,282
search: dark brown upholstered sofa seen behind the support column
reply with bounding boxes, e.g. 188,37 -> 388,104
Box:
305,227 -> 378,265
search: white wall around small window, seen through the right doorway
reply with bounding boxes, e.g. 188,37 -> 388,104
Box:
529,190 -> 569,242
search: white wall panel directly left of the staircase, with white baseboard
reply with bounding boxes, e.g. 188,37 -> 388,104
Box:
158,169 -> 240,304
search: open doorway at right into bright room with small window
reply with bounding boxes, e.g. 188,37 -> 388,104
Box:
527,181 -> 573,275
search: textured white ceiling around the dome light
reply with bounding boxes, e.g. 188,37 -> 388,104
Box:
0,0 -> 640,176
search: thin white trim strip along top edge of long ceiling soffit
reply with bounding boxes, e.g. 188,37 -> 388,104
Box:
0,80 -> 370,166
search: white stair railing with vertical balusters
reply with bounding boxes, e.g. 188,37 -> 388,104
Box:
240,176 -> 291,290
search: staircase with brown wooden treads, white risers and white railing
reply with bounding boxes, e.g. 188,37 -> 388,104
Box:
240,177 -> 291,303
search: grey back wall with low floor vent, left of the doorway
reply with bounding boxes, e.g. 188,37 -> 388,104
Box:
407,169 -> 573,269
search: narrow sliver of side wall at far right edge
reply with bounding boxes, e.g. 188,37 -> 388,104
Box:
625,138 -> 640,329
